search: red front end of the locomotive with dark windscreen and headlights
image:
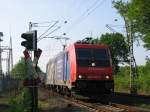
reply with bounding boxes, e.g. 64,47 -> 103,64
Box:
68,44 -> 114,94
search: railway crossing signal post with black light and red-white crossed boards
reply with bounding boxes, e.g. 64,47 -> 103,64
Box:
21,30 -> 42,112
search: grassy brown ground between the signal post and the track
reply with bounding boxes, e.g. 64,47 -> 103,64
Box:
39,89 -> 89,112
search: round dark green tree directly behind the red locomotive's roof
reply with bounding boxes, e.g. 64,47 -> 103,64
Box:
96,33 -> 129,72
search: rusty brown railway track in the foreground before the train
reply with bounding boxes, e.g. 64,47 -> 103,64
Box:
44,88 -> 150,112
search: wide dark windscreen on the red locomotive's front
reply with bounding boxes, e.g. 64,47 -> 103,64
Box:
76,48 -> 110,67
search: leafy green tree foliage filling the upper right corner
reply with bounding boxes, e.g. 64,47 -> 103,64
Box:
113,0 -> 150,50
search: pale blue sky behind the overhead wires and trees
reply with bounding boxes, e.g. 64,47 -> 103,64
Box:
0,0 -> 150,71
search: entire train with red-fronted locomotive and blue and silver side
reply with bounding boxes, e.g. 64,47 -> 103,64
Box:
45,43 -> 114,98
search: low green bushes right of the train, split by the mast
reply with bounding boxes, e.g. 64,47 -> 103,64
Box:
114,60 -> 150,94
